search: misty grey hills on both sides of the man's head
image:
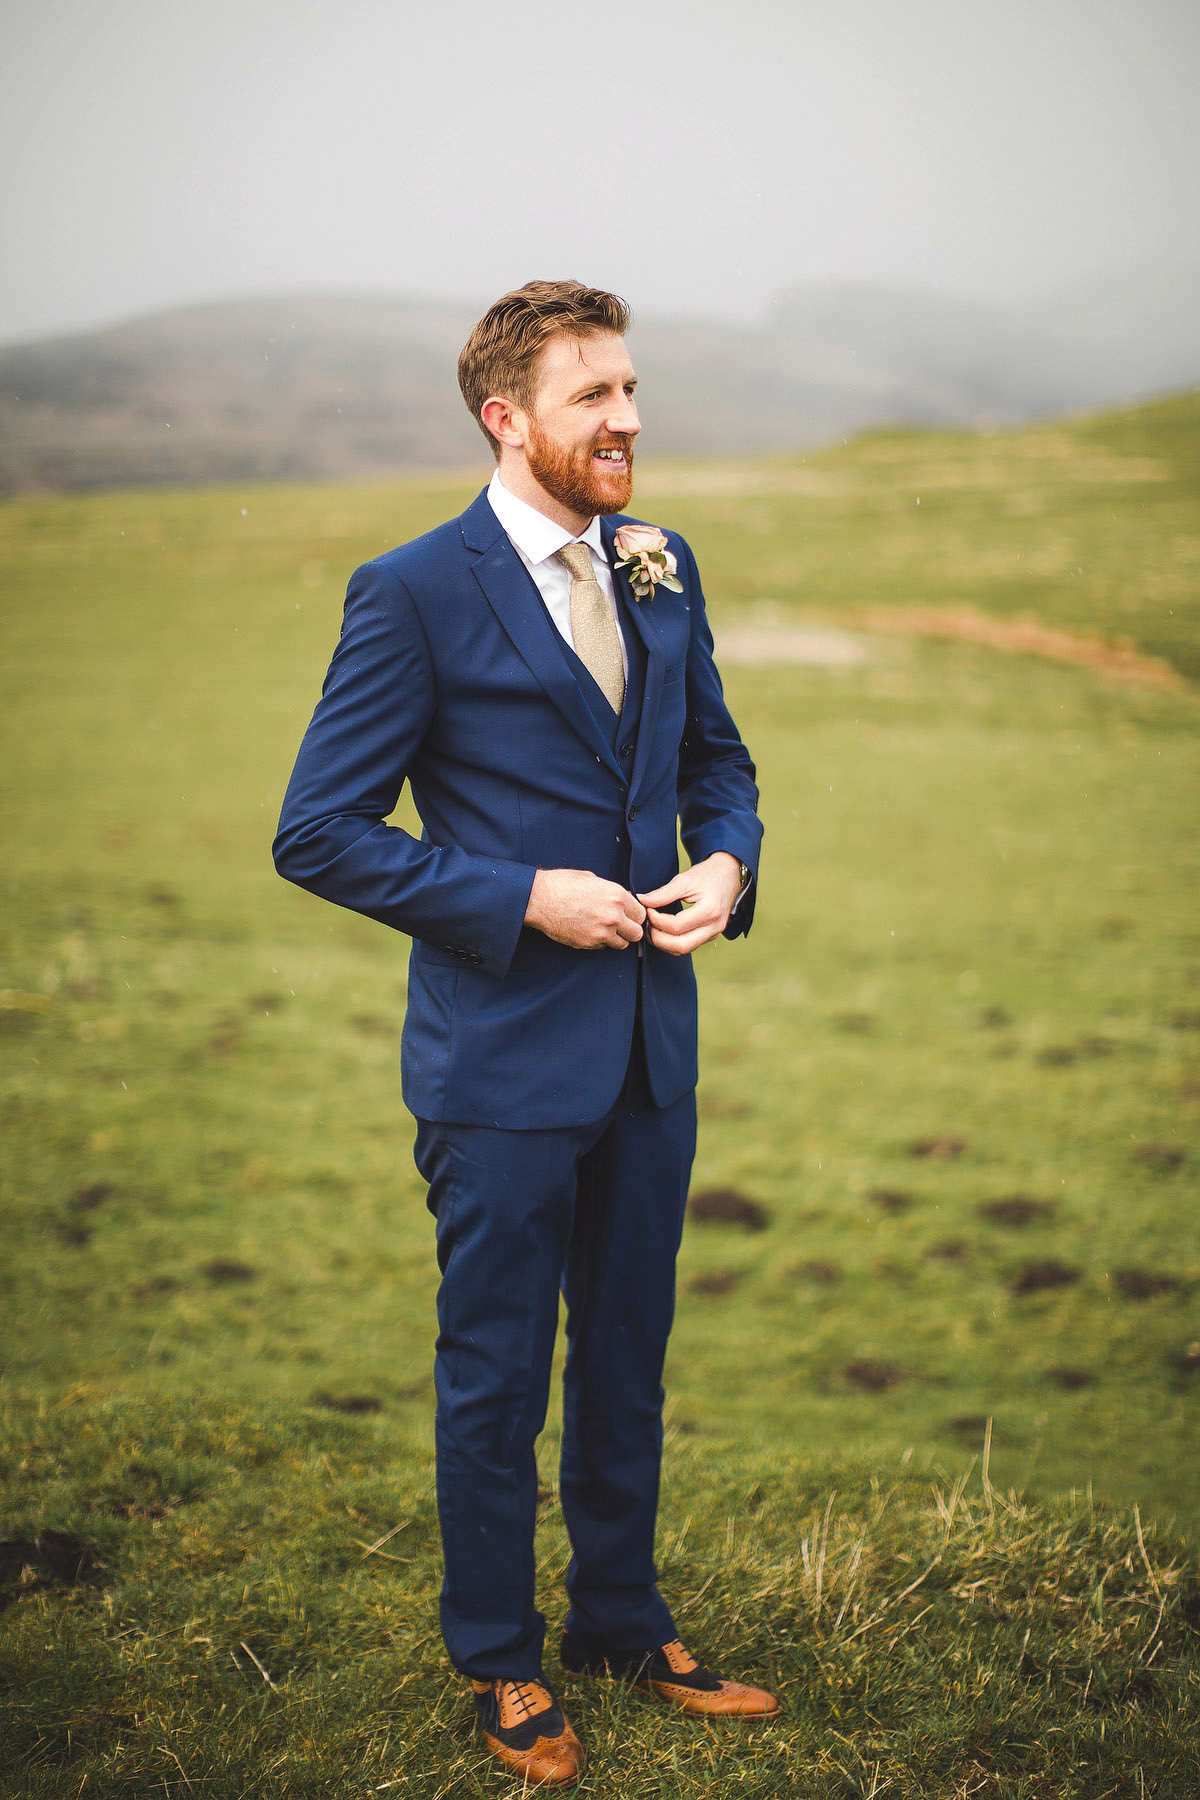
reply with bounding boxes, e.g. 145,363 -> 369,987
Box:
0,266 -> 1200,491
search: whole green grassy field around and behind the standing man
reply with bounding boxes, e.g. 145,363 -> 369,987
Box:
0,396 -> 1200,1800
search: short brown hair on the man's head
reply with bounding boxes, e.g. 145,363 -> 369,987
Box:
459,281 -> 630,457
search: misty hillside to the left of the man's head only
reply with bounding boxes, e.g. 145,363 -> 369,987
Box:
0,295 -> 486,490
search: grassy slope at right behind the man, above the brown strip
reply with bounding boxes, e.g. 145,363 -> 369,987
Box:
639,392 -> 1200,680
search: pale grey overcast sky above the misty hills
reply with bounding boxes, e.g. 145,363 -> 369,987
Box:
0,0 -> 1200,340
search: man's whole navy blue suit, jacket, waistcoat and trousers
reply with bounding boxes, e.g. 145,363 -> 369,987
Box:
275,495 -> 761,1679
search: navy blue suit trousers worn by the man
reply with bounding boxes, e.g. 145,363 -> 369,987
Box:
414,1031 -> 696,1681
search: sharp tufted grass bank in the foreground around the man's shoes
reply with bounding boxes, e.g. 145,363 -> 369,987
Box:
0,1402 -> 1200,1800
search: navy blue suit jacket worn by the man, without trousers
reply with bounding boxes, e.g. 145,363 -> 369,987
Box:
273,493 -> 761,1130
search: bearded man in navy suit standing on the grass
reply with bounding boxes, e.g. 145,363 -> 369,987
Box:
275,281 -> 779,1786
